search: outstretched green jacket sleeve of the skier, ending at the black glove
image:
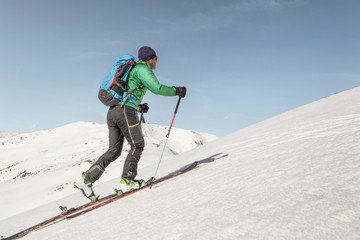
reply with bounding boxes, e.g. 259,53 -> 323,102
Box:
137,66 -> 176,96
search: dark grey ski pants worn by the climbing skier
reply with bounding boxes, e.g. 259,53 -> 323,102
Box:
85,106 -> 145,183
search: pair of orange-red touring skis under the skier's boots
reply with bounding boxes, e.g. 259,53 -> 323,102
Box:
3,161 -> 198,240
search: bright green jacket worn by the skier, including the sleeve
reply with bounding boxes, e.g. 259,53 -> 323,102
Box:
121,60 -> 176,110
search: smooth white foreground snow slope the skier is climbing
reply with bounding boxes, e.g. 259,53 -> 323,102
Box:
0,88 -> 360,240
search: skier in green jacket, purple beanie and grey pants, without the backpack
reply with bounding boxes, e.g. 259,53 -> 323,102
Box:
74,46 -> 186,201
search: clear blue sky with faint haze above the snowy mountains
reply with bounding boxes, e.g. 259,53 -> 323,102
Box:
0,0 -> 360,136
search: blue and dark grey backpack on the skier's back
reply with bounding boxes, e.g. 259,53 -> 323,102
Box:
98,55 -> 136,107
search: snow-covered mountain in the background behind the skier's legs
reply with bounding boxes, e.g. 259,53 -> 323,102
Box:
0,122 -> 217,221
